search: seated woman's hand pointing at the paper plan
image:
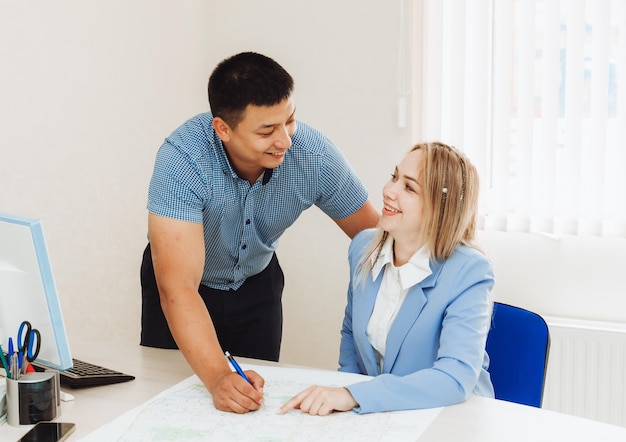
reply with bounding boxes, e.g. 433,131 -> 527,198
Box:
278,385 -> 358,416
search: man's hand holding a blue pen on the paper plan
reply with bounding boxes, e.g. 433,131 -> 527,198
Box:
209,370 -> 265,414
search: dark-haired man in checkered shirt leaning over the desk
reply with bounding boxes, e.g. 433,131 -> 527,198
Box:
141,52 -> 379,413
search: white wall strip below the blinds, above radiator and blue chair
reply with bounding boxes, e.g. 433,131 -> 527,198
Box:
478,231 -> 626,323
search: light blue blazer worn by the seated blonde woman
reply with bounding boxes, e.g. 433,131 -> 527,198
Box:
339,229 -> 494,413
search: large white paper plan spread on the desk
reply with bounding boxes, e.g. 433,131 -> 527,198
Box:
83,364 -> 441,442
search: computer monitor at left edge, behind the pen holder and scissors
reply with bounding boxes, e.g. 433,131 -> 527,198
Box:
0,213 -> 72,370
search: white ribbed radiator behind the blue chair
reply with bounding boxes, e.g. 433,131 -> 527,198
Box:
542,317 -> 626,427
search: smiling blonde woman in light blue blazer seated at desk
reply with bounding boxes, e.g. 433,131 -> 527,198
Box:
280,143 -> 494,415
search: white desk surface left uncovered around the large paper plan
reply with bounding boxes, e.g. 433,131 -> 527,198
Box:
0,342 -> 626,442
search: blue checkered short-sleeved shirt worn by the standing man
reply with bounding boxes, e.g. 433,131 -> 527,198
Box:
148,113 -> 368,290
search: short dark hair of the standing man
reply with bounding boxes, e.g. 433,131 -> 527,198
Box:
208,52 -> 293,128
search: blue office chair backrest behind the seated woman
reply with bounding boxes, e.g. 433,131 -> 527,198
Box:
486,302 -> 550,408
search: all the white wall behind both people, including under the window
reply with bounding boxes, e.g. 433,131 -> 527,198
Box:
0,0 -> 626,368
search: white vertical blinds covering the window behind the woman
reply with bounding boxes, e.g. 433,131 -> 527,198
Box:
414,0 -> 626,237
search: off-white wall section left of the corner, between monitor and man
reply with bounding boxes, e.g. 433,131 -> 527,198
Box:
0,0 -> 215,342
